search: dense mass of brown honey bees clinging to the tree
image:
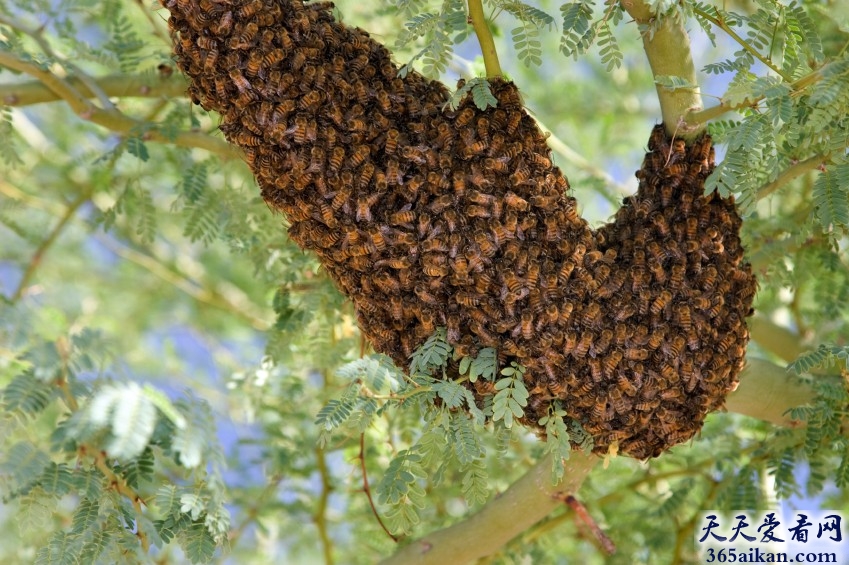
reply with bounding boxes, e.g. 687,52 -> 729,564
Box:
163,0 -> 755,458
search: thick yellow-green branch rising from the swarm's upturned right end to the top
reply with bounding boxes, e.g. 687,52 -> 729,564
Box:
621,0 -> 704,140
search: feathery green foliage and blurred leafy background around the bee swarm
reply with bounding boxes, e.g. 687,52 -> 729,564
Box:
0,0 -> 849,563
